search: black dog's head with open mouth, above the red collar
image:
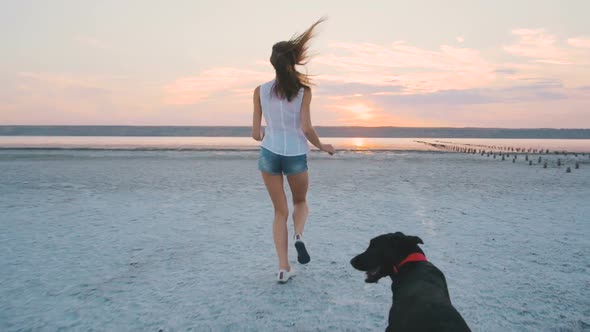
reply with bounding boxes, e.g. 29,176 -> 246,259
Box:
350,232 -> 424,283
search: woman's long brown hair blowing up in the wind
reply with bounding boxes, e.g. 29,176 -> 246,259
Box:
270,17 -> 326,101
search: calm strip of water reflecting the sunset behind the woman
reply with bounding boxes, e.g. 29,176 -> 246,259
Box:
0,136 -> 590,152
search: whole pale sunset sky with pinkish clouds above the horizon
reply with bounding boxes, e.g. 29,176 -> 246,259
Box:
0,0 -> 590,128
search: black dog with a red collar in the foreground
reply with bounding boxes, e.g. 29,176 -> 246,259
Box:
350,232 -> 471,332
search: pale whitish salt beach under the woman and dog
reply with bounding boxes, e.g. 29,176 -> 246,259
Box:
0,149 -> 590,331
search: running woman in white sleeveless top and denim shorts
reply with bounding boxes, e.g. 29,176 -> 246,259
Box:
252,19 -> 335,283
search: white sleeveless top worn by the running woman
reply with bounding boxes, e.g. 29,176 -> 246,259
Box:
260,80 -> 309,156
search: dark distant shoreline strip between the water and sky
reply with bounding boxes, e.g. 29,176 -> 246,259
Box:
0,125 -> 590,139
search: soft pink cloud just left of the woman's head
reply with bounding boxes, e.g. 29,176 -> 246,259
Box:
164,67 -> 272,105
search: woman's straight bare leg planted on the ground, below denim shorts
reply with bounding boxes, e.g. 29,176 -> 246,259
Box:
262,172 -> 291,271
